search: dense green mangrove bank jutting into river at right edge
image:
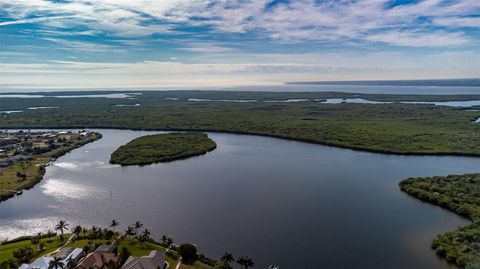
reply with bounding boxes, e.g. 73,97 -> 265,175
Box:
400,174 -> 480,268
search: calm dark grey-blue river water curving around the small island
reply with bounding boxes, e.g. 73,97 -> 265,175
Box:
0,130 -> 480,269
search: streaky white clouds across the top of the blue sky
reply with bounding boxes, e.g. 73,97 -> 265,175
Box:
0,0 -> 480,46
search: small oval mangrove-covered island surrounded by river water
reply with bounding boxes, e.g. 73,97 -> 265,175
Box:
110,132 -> 217,165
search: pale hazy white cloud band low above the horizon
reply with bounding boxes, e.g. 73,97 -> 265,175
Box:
0,51 -> 480,88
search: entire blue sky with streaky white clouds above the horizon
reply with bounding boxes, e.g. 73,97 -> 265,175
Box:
0,0 -> 480,90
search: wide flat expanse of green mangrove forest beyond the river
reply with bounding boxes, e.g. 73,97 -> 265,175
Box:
0,91 -> 480,156
